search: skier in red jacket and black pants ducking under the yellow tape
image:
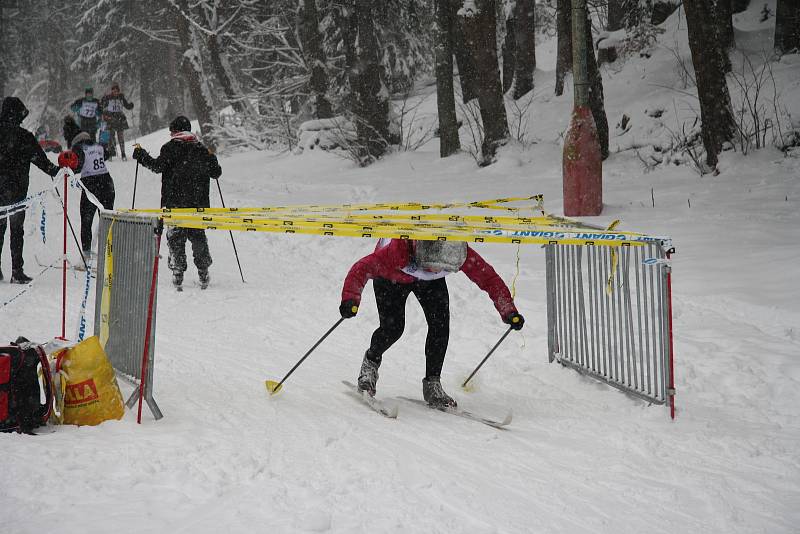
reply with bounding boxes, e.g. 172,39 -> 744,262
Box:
339,239 -> 525,407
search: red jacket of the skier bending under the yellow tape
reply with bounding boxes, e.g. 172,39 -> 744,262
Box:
342,239 -> 517,318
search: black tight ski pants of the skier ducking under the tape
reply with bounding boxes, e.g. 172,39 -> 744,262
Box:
367,278 -> 450,377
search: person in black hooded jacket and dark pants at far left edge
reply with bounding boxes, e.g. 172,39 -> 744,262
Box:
0,96 -> 58,284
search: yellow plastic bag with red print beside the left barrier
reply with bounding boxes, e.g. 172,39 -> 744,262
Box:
58,336 -> 125,425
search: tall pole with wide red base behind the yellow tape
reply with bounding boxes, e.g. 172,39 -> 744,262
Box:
562,0 -> 603,216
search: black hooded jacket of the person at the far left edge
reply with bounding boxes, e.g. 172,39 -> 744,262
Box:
0,96 -> 58,204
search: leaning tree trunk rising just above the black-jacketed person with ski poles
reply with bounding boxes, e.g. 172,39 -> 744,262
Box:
176,0 -> 214,150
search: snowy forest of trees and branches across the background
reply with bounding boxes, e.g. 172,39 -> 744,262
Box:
0,0 -> 800,168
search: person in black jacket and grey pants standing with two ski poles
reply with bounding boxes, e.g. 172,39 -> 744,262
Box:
133,116 -> 222,291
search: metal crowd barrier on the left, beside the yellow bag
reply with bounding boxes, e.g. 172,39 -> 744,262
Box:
94,212 -> 163,419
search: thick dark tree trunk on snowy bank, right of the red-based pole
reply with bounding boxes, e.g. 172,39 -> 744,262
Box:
683,0 -> 736,167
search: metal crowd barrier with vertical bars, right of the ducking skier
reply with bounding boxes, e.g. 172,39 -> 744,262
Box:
545,242 -> 674,417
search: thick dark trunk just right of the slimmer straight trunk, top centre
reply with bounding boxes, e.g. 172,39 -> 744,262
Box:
461,0 -> 509,165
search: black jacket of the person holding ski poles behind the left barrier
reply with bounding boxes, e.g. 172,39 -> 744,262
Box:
134,132 -> 222,208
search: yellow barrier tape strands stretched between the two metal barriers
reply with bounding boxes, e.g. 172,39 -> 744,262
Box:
120,195 -> 663,247
